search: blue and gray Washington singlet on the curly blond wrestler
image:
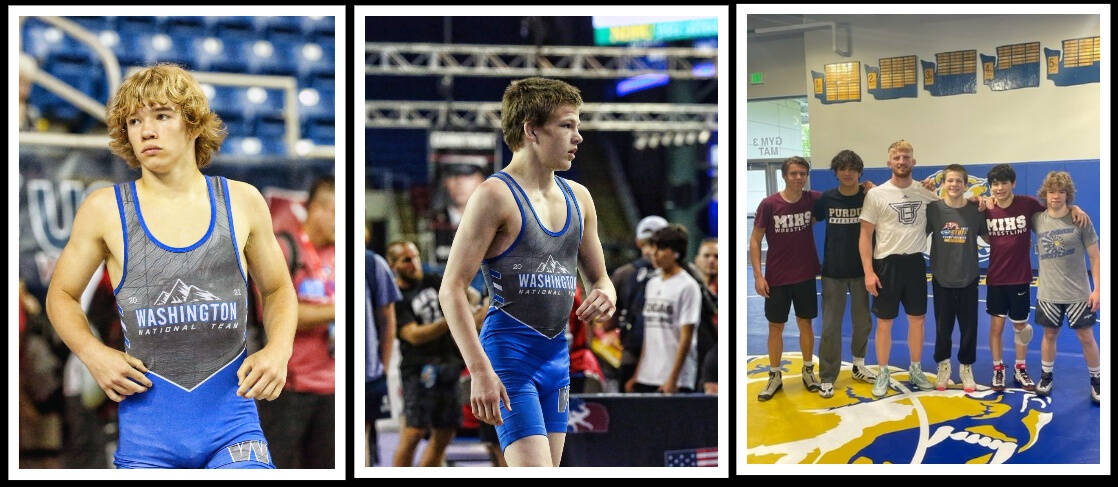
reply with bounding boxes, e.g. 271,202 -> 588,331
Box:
114,178 -> 274,468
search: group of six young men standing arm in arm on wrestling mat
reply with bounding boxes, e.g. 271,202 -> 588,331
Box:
749,141 -> 1099,402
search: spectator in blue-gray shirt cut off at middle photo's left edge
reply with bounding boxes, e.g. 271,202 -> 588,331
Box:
364,249 -> 404,466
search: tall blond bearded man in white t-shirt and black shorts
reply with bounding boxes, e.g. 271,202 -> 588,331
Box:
858,141 -> 939,398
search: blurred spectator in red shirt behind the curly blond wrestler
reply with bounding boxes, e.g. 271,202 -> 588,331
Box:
257,176 -> 334,468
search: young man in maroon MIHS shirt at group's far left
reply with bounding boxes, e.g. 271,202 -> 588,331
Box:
749,156 -> 821,401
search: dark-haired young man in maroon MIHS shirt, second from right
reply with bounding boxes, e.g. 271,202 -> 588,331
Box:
986,164 -> 1090,391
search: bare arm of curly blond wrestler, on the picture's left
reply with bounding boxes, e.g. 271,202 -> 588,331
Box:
47,188 -> 152,402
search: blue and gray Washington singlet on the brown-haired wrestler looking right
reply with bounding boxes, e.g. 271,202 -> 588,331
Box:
481,172 -> 582,450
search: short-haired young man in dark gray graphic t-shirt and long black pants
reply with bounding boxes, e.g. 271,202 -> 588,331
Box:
925,164 -> 986,392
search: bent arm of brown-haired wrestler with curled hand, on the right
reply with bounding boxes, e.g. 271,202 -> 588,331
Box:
570,181 -> 617,323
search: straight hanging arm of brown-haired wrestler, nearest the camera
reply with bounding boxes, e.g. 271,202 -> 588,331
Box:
438,179 -> 517,424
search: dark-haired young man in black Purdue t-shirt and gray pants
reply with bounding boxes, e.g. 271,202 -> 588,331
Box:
813,150 -> 874,398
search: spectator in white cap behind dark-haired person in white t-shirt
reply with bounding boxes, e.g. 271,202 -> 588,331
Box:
607,216 -> 667,393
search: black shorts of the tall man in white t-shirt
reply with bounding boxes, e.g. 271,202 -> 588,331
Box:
871,254 -> 928,319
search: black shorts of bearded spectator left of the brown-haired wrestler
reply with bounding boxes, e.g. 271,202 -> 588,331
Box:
400,364 -> 462,429
